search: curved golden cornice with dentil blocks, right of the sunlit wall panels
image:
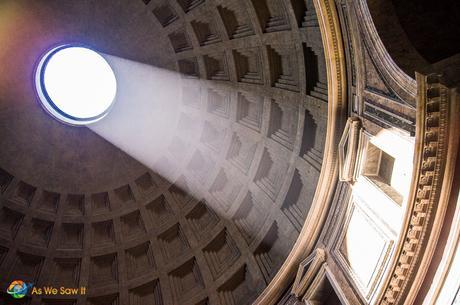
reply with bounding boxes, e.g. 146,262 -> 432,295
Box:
378,74 -> 460,305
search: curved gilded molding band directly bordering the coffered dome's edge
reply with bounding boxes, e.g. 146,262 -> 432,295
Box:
254,0 -> 347,305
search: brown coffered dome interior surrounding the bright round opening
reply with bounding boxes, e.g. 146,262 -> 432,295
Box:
0,0 -> 327,305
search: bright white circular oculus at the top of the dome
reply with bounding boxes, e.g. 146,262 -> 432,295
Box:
36,45 -> 117,125
